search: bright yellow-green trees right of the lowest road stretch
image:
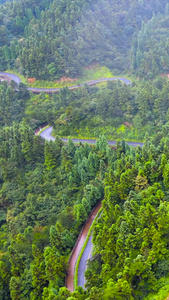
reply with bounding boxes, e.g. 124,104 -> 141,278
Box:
86,137 -> 169,299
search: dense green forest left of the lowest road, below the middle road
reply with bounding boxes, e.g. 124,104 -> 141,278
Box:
0,114 -> 106,299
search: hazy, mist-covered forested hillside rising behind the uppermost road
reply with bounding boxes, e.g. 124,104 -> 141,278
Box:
0,0 -> 168,79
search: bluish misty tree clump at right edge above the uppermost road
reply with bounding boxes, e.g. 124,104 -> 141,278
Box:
132,13 -> 169,78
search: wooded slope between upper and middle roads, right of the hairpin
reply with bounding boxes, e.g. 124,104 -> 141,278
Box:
50,79 -> 169,141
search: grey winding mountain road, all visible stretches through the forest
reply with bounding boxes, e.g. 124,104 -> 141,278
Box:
0,72 -> 143,292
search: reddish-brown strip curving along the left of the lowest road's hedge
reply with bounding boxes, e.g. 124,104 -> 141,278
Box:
66,202 -> 101,292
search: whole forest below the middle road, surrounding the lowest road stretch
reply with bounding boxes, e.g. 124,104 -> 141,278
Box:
0,95 -> 169,300
